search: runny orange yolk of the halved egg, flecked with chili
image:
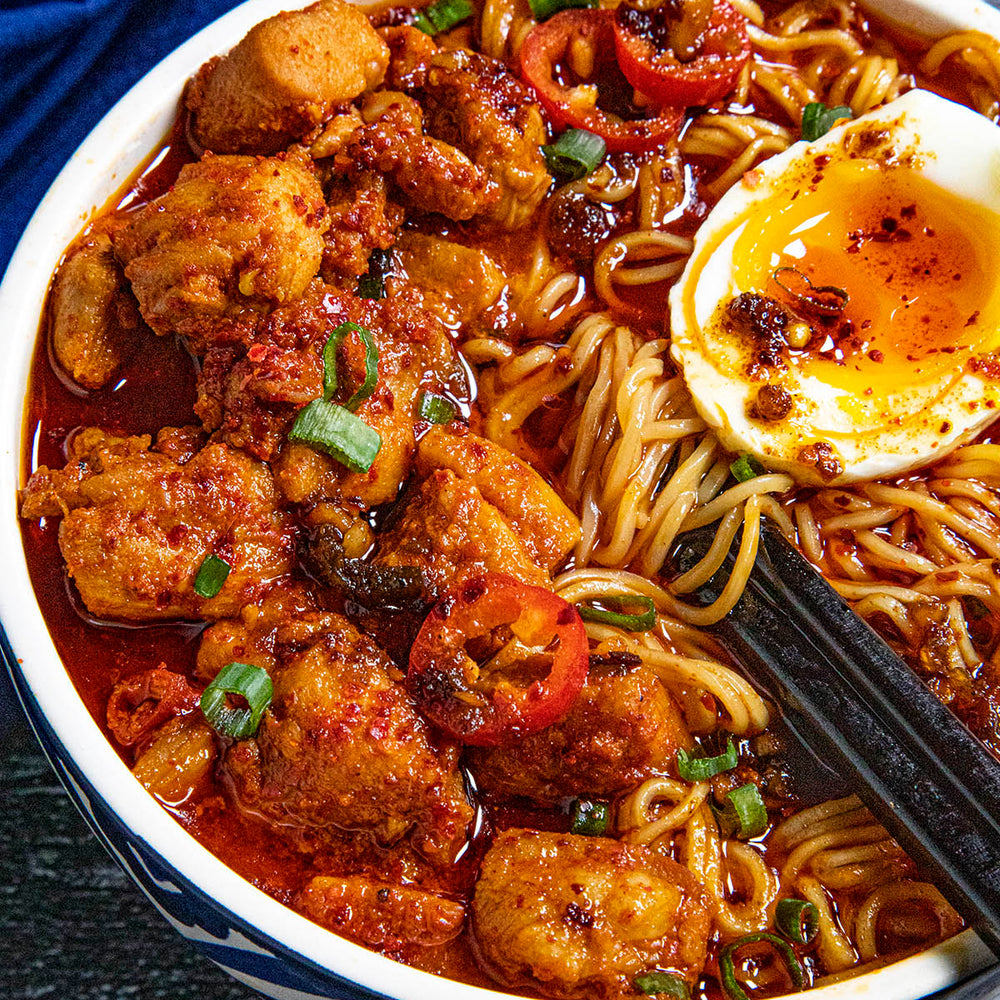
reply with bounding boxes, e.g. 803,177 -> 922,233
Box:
733,159 -> 1000,396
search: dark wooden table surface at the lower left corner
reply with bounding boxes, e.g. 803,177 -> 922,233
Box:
0,667 -> 260,1000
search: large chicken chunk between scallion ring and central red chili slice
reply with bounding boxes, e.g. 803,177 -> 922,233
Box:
226,618 -> 473,863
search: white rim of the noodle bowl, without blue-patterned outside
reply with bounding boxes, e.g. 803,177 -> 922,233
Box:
0,0 -> 1000,1000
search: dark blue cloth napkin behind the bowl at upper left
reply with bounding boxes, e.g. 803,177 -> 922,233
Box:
0,0 -> 242,274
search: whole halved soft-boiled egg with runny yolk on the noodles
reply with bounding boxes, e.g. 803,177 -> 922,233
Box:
670,90 -> 1000,485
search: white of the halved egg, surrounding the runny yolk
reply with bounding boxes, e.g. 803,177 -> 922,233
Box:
670,90 -> 1000,485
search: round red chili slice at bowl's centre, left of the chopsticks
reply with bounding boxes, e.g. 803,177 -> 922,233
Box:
406,573 -> 588,746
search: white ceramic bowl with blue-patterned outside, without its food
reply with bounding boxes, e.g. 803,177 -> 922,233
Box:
0,0 -> 1000,1000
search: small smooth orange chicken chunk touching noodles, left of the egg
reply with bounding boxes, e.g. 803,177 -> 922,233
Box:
387,232 -> 507,330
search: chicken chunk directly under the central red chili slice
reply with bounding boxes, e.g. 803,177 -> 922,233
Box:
469,666 -> 691,805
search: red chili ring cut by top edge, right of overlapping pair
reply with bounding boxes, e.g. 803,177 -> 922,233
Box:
614,0 -> 750,107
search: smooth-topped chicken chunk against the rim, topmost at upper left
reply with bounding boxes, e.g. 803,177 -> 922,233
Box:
186,0 -> 389,154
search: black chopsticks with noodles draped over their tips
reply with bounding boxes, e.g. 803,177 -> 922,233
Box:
677,523 -> 1000,956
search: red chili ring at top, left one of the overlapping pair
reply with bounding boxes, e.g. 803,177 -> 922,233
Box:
521,10 -> 684,152
